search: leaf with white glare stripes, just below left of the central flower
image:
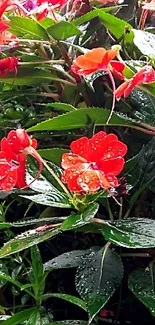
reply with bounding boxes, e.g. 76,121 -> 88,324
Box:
21,192 -> 72,208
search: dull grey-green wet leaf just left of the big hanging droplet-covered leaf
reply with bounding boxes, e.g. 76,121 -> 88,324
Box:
44,247 -> 99,271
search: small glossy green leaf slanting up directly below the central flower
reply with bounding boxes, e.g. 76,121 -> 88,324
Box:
61,203 -> 99,230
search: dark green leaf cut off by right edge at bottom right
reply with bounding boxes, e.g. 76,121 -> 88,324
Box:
128,266 -> 155,317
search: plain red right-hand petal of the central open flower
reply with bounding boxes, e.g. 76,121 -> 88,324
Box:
97,157 -> 125,176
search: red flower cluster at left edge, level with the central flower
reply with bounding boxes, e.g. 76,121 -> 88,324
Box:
0,129 -> 37,191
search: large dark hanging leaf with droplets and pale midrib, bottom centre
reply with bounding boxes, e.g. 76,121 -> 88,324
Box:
76,246 -> 123,323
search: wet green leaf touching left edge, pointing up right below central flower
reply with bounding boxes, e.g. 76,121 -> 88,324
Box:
0,229 -> 60,258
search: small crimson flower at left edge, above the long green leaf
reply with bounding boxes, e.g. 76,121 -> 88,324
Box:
0,57 -> 18,76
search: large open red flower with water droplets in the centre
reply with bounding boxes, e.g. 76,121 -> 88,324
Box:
61,131 -> 127,193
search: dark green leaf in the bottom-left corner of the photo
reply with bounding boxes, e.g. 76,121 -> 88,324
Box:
2,307 -> 36,325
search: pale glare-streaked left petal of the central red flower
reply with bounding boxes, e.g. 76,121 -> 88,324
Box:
61,153 -> 87,169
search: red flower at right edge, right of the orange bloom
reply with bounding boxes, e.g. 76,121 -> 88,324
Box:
115,65 -> 155,99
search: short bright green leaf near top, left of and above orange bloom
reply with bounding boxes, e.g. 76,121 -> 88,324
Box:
47,21 -> 81,40
